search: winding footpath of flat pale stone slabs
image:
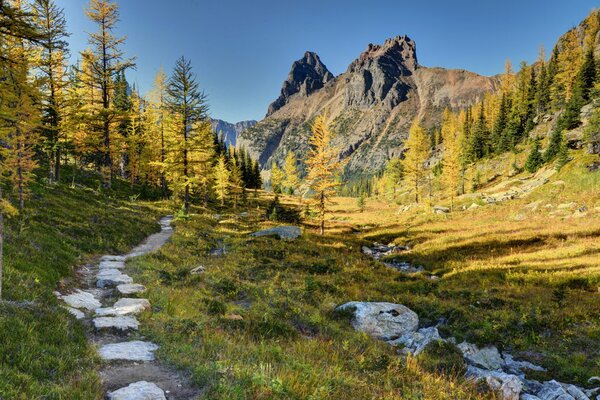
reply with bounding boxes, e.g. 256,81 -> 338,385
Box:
56,216 -> 199,400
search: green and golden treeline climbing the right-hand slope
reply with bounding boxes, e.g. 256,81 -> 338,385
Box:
368,10 -> 600,206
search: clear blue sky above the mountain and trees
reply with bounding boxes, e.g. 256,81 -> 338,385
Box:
56,0 -> 598,122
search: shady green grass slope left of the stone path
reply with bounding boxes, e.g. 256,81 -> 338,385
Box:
0,167 -> 166,400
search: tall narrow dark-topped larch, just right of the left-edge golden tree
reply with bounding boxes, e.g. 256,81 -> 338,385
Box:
33,0 -> 69,181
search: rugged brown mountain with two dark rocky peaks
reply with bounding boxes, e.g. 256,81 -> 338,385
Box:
238,36 -> 499,174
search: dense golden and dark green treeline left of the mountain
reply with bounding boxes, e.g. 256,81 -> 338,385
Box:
0,0 -> 260,216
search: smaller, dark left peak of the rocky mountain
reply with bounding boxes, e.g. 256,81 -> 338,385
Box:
267,51 -> 334,116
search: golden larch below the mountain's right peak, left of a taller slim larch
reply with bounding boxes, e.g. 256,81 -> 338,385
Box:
402,118 -> 429,203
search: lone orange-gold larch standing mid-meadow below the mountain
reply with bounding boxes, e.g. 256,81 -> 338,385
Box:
305,115 -> 345,235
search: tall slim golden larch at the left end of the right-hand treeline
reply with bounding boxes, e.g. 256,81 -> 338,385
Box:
442,110 -> 462,211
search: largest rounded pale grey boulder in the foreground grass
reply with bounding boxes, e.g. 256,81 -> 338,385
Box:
336,301 -> 419,340
